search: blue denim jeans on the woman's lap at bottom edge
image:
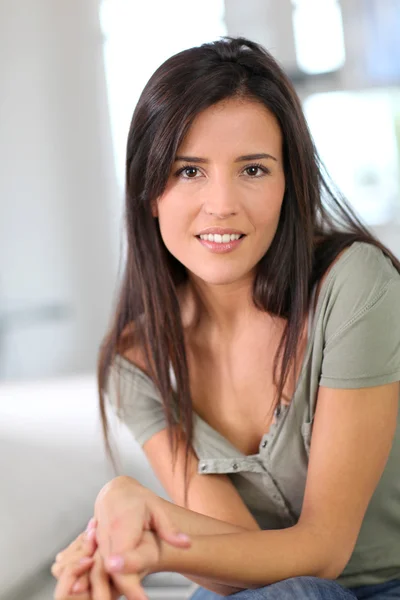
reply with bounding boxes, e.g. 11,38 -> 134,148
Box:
190,577 -> 400,600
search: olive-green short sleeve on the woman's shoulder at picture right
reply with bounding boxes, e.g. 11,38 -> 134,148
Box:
320,245 -> 400,388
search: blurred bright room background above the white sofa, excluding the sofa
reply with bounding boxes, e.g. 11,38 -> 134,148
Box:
0,0 -> 400,380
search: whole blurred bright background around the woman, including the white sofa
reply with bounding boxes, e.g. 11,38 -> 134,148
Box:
0,0 -> 400,600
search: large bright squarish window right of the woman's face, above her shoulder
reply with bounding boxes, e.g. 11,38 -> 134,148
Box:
304,89 -> 400,226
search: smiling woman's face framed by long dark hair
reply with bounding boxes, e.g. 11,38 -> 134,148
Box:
153,99 -> 285,285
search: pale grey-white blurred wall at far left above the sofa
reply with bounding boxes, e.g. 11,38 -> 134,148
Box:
0,0 -> 120,378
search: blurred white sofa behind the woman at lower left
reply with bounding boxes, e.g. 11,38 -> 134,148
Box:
0,374 -> 197,600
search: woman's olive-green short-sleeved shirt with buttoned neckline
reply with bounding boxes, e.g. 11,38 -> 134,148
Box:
108,242 -> 400,587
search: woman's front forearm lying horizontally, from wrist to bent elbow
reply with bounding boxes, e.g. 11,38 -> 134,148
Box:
157,525 -> 338,589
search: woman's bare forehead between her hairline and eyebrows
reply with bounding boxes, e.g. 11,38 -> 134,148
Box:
180,99 -> 282,151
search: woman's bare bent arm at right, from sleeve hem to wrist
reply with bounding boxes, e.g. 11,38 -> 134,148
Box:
108,382 -> 399,593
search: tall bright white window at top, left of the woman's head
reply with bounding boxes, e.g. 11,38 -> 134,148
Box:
100,0 -> 227,186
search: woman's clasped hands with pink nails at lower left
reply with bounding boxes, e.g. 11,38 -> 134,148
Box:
51,477 -> 191,600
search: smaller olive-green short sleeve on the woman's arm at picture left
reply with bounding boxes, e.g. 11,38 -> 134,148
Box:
106,355 -> 167,446
